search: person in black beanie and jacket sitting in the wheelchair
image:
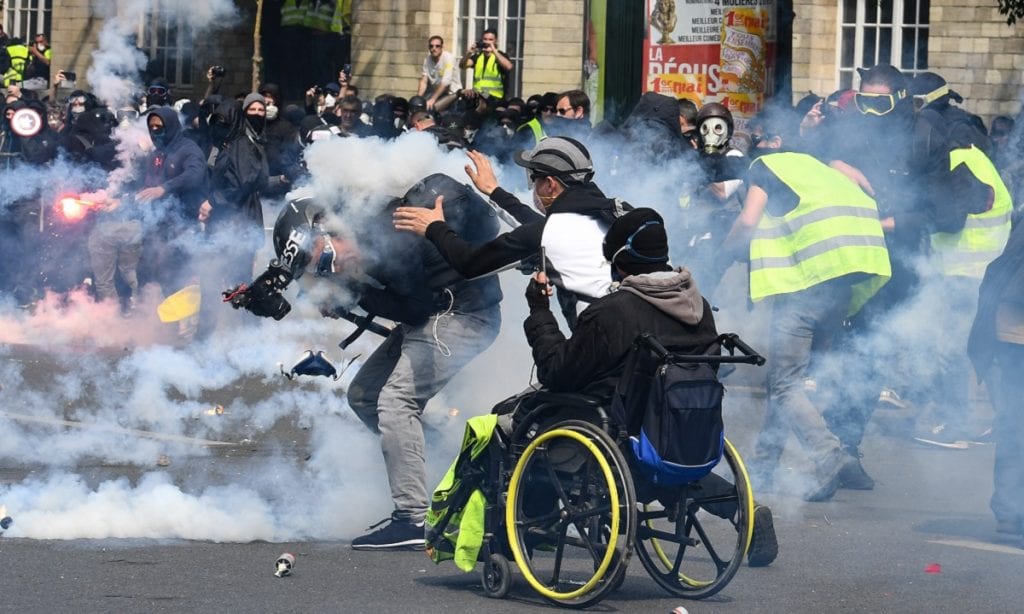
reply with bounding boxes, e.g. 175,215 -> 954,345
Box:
520,209 -> 778,566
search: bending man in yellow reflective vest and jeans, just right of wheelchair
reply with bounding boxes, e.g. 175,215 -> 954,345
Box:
725,112 -> 892,501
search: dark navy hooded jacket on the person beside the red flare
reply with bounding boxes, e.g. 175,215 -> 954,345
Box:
142,106 -> 206,219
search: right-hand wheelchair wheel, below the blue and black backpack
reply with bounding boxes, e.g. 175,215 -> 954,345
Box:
636,440 -> 754,599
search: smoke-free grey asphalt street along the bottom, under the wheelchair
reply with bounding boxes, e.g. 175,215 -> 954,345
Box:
0,374 -> 1024,614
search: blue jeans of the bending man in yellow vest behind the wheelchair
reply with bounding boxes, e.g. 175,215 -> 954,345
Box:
752,279 -> 851,479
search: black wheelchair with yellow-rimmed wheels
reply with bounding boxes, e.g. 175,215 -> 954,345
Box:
419,334 -> 764,608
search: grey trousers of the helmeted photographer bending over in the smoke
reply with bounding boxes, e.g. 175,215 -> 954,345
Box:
348,305 -> 501,523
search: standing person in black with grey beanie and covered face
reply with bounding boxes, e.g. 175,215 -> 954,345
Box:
201,93 -> 269,282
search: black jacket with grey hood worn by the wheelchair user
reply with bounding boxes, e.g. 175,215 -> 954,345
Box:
523,269 -> 717,399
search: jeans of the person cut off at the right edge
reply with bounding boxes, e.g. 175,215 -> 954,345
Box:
988,343 -> 1024,523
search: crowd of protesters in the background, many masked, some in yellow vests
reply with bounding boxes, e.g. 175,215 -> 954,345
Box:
0,25 -> 1024,548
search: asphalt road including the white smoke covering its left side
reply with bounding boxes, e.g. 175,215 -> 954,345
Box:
0,280 -> 1024,614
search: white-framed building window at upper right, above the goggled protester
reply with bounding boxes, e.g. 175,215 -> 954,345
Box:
838,0 -> 931,89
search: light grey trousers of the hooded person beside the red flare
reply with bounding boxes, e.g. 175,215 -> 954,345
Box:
89,220 -> 142,301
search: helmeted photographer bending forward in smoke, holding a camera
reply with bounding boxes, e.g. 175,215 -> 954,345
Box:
227,174 -> 502,550
